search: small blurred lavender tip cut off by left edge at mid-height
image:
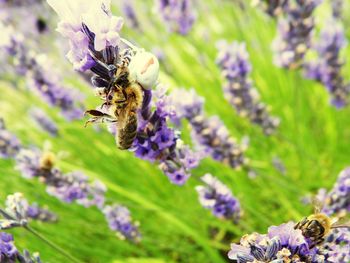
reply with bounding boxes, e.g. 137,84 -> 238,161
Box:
0,118 -> 21,158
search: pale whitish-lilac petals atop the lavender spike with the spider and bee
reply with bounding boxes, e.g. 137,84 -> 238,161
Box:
47,0 -> 123,71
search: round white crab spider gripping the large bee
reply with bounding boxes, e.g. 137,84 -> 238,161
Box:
121,38 -> 159,90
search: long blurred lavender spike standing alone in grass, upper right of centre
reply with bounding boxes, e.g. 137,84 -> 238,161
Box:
217,40 -> 279,135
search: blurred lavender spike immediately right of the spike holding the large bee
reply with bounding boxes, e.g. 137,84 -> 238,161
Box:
167,89 -> 247,168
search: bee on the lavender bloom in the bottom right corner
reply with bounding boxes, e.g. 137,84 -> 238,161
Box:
294,201 -> 350,248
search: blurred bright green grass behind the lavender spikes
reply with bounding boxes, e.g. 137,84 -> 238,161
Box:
0,0 -> 350,263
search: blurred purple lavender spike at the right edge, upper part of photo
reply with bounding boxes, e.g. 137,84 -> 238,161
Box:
305,21 -> 350,108
